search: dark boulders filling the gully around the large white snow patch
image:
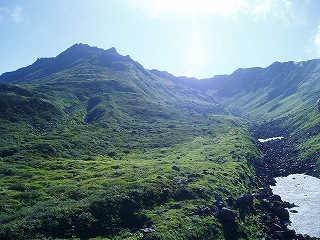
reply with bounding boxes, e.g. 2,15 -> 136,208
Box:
250,125 -> 320,240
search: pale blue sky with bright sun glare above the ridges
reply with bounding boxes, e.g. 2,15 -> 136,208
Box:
0,0 -> 320,79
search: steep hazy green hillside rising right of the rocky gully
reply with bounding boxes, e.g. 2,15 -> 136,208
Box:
197,59 -> 320,172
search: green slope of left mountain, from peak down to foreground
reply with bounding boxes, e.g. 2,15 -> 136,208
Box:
0,44 -> 263,239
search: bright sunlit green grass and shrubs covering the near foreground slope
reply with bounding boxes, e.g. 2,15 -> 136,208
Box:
1,133 -> 257,239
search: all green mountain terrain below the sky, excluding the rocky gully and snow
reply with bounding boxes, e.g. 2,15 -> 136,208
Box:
0,44 -> 320,239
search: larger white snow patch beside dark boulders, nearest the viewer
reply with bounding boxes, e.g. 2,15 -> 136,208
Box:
271,174 -> 320,237
